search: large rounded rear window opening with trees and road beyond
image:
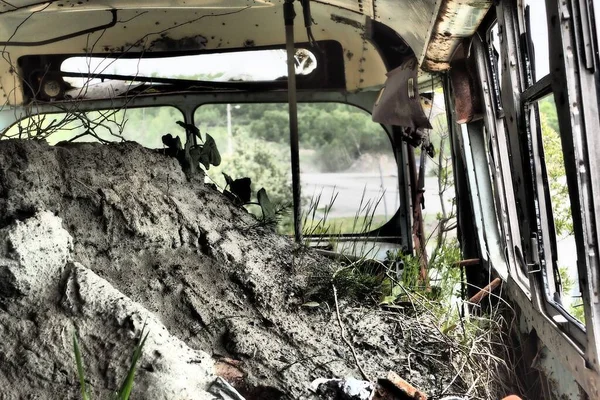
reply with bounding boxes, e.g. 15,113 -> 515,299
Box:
194,103 -> 400,252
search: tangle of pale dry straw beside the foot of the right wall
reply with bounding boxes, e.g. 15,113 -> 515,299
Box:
390,278 -> 523,400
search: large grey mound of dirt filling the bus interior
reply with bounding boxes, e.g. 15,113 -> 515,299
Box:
0,140 -> 453,399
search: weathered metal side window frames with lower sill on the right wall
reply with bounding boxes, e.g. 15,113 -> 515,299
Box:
486,0 -> 600,398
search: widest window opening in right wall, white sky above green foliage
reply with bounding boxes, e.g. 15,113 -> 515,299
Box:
521,0 -> 585,332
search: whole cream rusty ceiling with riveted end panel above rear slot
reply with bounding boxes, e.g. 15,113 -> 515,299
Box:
0,0 -> 491,104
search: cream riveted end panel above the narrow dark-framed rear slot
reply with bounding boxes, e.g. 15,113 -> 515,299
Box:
0,0 -> 386,104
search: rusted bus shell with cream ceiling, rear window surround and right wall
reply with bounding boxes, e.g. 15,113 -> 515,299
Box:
0,0 -> 600,399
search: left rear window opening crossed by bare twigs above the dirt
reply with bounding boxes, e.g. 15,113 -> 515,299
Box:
1,106 -> 185,149
